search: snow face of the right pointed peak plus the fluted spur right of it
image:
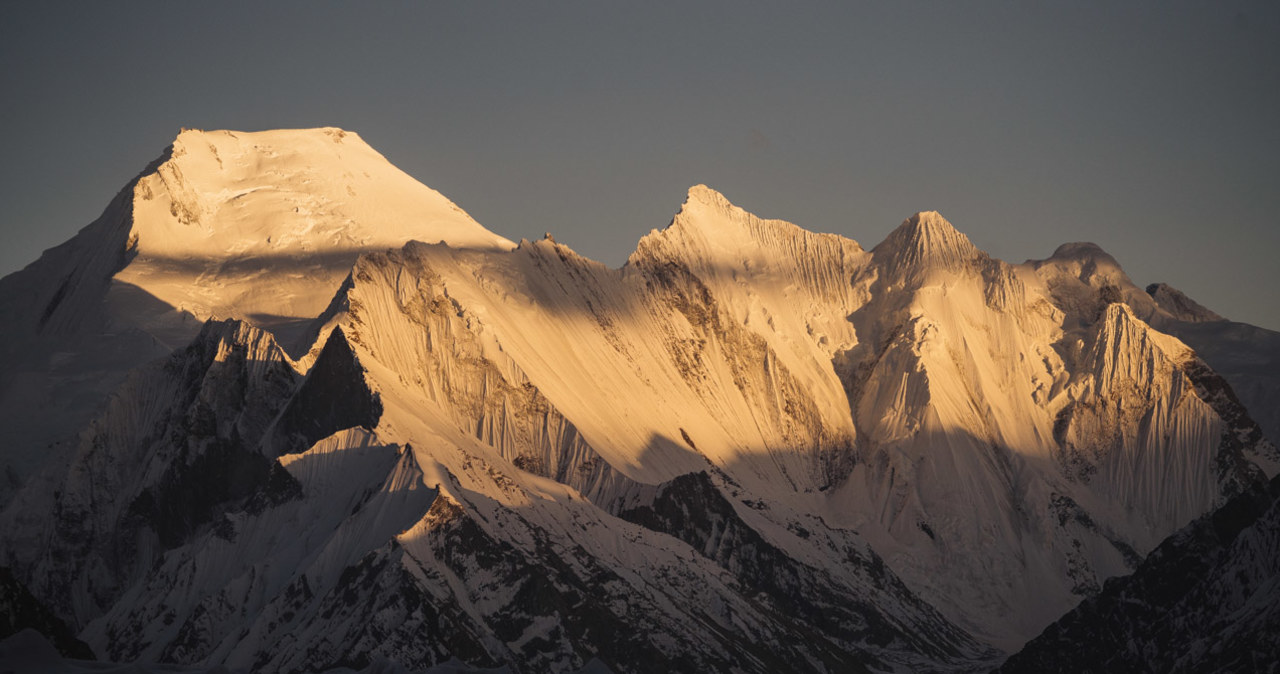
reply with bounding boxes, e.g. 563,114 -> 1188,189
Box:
814,222 -> 1275,646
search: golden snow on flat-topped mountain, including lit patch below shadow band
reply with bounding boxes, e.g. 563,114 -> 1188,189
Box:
115,129 -> 513,341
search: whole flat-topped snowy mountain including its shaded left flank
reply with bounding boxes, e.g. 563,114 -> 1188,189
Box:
0,128 -> 513,503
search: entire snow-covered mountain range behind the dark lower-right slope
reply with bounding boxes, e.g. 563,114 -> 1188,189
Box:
0,129 -> 1280,671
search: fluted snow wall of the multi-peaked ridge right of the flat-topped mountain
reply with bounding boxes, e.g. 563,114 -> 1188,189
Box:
294,193 -> 1261,645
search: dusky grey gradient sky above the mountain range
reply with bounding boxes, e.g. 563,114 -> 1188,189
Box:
0,1 -> 1280,329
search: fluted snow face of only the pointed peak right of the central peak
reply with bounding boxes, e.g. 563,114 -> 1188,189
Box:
826,214 -> 1131,645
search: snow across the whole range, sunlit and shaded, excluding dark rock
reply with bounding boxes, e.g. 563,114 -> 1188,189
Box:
0,129 -> 1274,669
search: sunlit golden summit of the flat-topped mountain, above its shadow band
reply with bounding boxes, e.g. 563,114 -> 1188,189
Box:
133,127 -> 513,258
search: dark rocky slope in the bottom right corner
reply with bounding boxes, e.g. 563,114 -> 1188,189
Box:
1000,480 -> 1280,671
